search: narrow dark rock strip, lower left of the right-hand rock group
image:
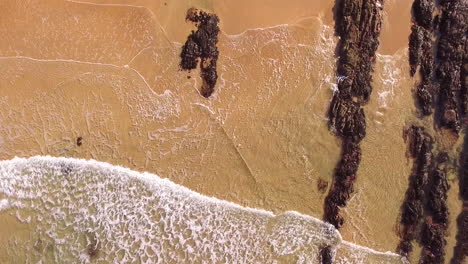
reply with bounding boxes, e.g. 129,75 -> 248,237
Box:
398,126 -> 433,256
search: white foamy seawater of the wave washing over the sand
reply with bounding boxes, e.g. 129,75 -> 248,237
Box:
0,156 -> 403,263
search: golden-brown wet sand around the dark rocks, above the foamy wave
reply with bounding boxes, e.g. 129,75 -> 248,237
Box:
0,0 -> 460,259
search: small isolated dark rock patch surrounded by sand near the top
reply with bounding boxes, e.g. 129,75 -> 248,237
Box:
180,8 -> 219,98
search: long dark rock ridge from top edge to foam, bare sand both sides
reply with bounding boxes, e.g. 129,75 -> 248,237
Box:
321,0 -> 383,264
